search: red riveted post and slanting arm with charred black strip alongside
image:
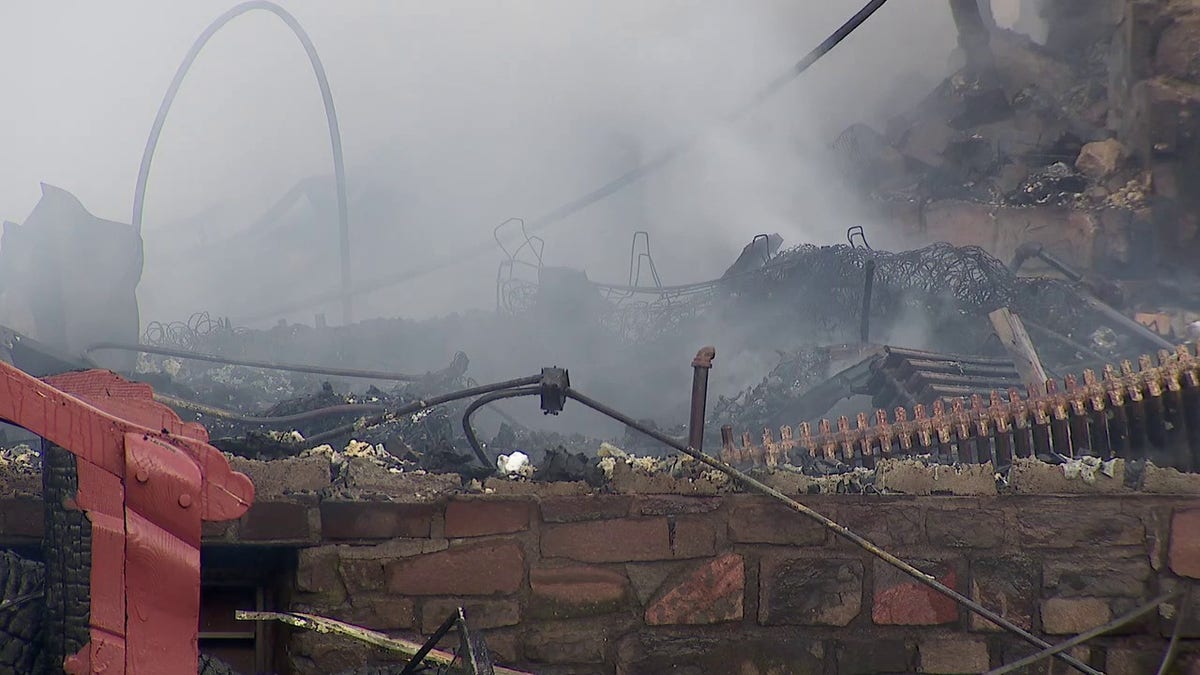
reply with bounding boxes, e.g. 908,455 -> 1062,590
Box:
0,363 -> 254,674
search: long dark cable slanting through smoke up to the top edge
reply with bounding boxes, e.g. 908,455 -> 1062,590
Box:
244,0 -> 888,322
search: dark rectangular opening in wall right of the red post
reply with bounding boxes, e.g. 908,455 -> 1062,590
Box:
199,546 -> 296,675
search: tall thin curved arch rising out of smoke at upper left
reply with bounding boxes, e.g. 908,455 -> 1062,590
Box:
133,0 -> 352,323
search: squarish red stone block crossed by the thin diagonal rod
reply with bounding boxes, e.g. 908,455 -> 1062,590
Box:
871,560 -> 961,626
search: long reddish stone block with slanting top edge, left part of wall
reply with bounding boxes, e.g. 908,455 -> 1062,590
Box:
384,540 -> 526,596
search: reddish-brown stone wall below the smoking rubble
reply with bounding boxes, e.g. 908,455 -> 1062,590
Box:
177,451 -> 1200,675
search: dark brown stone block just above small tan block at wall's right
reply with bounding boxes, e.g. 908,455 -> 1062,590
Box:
1042,555 -> 1154,598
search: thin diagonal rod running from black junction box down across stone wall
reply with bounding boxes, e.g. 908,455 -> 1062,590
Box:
565,389 -> 1103,675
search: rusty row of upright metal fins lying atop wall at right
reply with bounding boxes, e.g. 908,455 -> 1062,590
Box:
722,346 -> 1200,471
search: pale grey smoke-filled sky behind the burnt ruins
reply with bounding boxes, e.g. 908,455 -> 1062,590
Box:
0,0 -> 954,318
